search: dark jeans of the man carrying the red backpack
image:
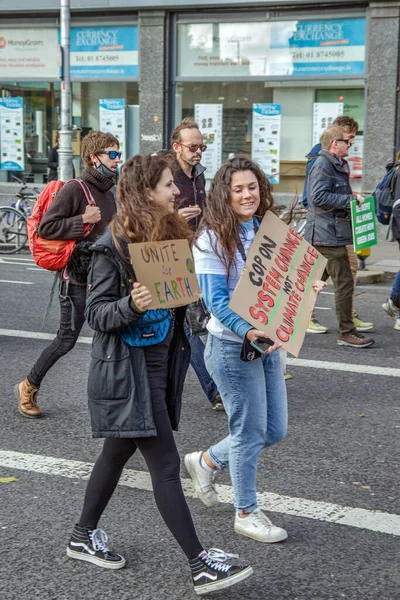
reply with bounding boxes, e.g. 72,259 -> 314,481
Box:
28,281 -> 86,387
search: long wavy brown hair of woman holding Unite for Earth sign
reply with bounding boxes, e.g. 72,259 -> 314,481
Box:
111,155 -> 193,254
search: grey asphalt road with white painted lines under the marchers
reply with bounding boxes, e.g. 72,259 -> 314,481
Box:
0,255 -> 400,600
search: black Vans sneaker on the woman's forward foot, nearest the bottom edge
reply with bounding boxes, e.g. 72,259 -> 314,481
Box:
189,548 -> 253,596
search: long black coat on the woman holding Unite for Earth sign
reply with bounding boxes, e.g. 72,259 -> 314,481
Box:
85,230 -> 190,438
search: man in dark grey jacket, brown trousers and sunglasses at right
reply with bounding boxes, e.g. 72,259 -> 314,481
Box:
304,126 -> 374,348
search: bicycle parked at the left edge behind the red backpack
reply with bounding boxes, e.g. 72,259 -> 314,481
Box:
0,175 -> 40,254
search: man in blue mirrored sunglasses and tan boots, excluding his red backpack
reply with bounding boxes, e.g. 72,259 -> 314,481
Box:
14,131 -> 121,419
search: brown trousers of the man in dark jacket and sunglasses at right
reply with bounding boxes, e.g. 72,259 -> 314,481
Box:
315,246 -> 354,335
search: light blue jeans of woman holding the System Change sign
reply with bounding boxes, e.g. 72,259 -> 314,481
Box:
204,335 -> 288,512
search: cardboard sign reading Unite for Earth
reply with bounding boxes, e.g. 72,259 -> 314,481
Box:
129,240 -> 201,308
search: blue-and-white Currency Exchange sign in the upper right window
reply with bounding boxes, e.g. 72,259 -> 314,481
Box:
269,18 -> 366,76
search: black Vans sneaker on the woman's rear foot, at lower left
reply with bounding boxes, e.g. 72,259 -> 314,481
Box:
67,525 -> 126,569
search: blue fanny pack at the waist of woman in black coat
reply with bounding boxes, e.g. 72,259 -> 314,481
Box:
118,308 -> 172,348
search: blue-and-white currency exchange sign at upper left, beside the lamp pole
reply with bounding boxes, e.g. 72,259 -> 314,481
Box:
71,26 -> 138,79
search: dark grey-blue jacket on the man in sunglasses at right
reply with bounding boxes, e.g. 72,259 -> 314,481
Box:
304,150 -> 357,246
